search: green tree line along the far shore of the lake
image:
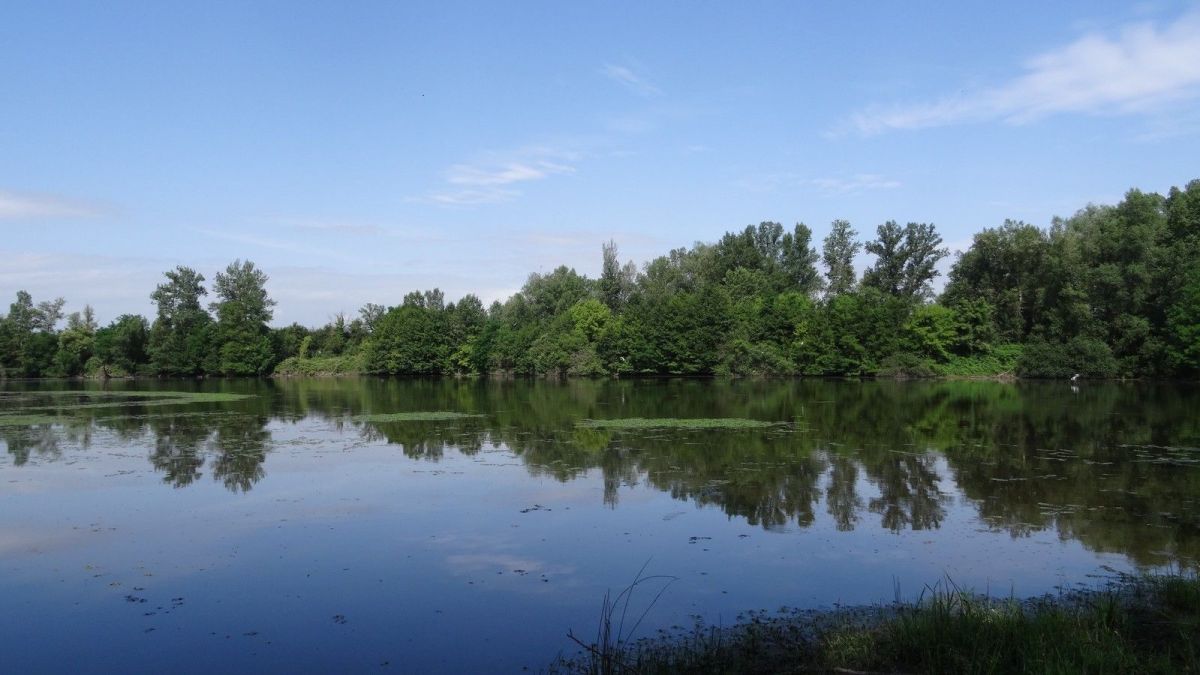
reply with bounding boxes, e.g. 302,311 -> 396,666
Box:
0,180 -> 1200,377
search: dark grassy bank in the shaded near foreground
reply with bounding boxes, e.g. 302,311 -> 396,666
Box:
550,574 -> 1200,675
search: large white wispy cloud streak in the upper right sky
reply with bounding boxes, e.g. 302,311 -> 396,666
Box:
835,13 -> 1200,136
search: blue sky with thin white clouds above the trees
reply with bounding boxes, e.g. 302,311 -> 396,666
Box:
0,1 -> 1200,324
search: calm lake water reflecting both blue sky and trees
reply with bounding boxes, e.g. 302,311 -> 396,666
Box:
0,380 -> 1200,673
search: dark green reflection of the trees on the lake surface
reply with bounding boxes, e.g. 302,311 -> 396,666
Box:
0,378 -> 1200,565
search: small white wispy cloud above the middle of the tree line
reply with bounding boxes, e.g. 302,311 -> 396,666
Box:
424,147 -> 578,207
